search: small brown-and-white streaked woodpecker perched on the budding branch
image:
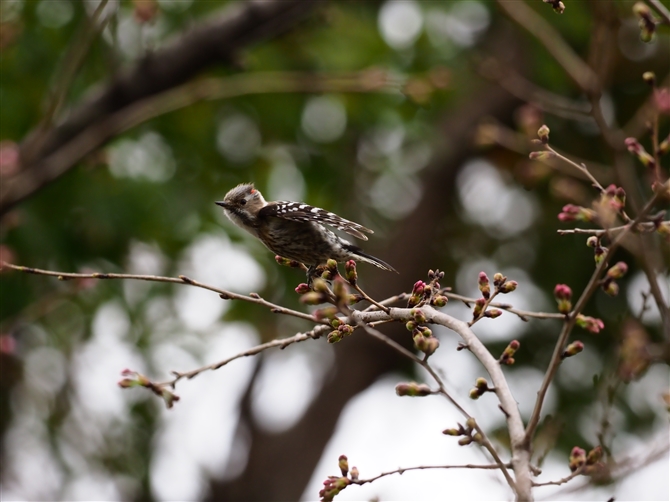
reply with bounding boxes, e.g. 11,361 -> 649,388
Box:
215,183 -> 398,283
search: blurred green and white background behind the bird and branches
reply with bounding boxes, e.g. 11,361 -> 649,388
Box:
0,0 -> 670,501
